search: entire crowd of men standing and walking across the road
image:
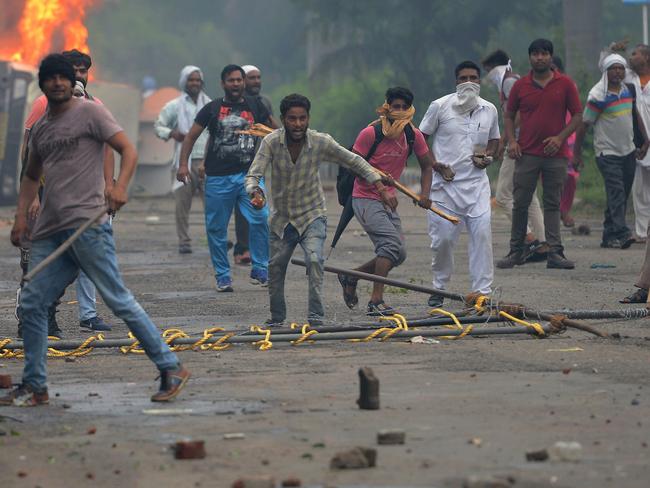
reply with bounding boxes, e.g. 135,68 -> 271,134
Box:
0,39 -> 650,406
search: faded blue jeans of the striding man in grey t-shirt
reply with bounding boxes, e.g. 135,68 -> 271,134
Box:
20,223 -> 179,390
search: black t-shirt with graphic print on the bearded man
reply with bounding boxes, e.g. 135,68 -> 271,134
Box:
194,98 -> 269,176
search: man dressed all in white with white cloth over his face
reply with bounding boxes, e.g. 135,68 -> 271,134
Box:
420,61 -> 500,307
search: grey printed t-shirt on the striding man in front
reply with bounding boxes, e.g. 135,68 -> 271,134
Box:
29,98 -> 122,240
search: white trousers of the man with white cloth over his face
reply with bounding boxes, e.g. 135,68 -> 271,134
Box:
428,209 -> 494,295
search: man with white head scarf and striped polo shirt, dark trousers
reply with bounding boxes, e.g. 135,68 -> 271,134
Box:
574,54 -> 647,249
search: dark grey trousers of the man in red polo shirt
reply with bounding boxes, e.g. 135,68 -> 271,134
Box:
510,154 -> 568,253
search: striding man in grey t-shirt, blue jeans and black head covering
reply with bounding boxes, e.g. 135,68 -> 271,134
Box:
0,54 -> 190,406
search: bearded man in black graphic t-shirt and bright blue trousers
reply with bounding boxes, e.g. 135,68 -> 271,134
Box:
176,64 -> 274,292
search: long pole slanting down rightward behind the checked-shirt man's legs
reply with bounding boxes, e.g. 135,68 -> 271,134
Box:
291,258 -> 608,337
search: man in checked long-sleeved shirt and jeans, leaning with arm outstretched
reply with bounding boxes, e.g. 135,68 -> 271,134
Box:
246,94 -> 390,326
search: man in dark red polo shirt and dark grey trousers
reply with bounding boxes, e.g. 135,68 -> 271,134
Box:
497,39 -> 582,269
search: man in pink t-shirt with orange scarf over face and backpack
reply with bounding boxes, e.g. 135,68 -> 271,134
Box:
339,87 -> 454,316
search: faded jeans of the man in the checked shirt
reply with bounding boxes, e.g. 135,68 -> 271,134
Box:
266,217 -> 327,322
